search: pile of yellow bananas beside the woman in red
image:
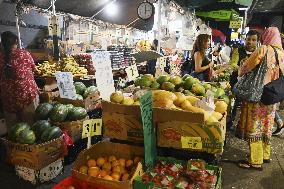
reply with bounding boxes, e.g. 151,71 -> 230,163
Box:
35,57 -> 88,76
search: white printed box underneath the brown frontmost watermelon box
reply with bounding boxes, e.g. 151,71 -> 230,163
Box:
15,158 -> 64,184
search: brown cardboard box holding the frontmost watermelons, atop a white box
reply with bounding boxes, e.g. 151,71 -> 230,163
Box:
2,136 -> 64,170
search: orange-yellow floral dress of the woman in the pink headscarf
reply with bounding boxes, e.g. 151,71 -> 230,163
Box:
236,46 -> 284,144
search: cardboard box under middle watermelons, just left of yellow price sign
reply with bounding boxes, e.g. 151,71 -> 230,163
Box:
54,119 -> 84,142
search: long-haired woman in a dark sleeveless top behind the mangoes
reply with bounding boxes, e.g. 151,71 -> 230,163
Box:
192,34 -> 213,81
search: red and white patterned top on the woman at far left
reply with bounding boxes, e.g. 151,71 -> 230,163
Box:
0,49 -> 38,113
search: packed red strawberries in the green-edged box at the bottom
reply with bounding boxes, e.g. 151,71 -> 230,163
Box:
139,160 -> 217,189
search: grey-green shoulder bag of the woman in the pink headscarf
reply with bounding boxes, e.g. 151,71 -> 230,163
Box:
235,48 -> 267,102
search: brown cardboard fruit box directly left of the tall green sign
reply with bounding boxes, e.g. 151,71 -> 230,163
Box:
102,101 -> 144,143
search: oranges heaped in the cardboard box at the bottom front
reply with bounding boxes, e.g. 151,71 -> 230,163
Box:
78,155 -> 142,181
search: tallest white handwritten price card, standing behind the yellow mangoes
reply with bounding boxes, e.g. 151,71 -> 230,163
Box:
92,51 -> 115,100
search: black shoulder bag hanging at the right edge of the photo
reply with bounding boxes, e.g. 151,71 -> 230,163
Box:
261,47 -> 284,105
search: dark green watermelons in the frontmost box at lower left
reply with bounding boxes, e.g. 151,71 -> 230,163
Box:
8,120 -> 62,144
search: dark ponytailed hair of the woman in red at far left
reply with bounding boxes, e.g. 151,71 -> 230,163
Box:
1,31 -> 18,79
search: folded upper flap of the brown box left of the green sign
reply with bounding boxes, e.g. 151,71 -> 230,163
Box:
102,101 -> 140,116
